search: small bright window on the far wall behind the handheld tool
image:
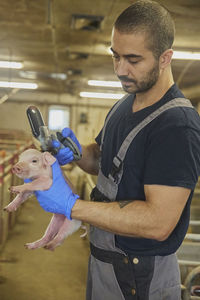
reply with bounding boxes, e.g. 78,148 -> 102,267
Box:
48,106 -> 70,131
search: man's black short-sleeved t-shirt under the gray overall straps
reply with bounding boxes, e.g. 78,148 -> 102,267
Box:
96,84 -> 200,255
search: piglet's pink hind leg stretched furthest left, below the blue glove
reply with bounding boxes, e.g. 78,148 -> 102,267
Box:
25,214 -> 66,249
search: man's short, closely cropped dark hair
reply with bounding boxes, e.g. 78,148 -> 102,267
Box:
114,0 -> 175,58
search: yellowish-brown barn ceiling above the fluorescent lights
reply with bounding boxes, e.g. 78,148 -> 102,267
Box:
0,0 -> 200,102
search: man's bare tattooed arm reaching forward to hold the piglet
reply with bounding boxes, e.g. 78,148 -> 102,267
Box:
71,185 -> 191,241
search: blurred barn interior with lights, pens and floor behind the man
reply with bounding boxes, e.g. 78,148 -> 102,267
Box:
0,0 -> 200,300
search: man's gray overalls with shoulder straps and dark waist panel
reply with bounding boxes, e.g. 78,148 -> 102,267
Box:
86,96 -> 193,300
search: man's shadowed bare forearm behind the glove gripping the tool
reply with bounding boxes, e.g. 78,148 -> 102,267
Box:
76,143 -> 100,175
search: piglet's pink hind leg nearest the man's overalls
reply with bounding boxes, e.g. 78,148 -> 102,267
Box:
45,217 -> 81,250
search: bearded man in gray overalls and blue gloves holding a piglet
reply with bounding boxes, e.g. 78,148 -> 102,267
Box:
35,1 -> 200,300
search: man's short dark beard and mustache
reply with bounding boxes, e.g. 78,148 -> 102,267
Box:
118,62 -> 159,94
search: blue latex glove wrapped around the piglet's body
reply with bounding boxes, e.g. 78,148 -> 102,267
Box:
24,160 -> 79,220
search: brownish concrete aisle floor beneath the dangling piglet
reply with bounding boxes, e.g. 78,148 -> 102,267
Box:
0,199 -> 89,300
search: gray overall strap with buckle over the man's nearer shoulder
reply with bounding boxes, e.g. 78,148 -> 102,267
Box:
109,98 -> 193,183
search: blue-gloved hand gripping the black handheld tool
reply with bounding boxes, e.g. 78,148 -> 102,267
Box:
52,127 -> 82,166
